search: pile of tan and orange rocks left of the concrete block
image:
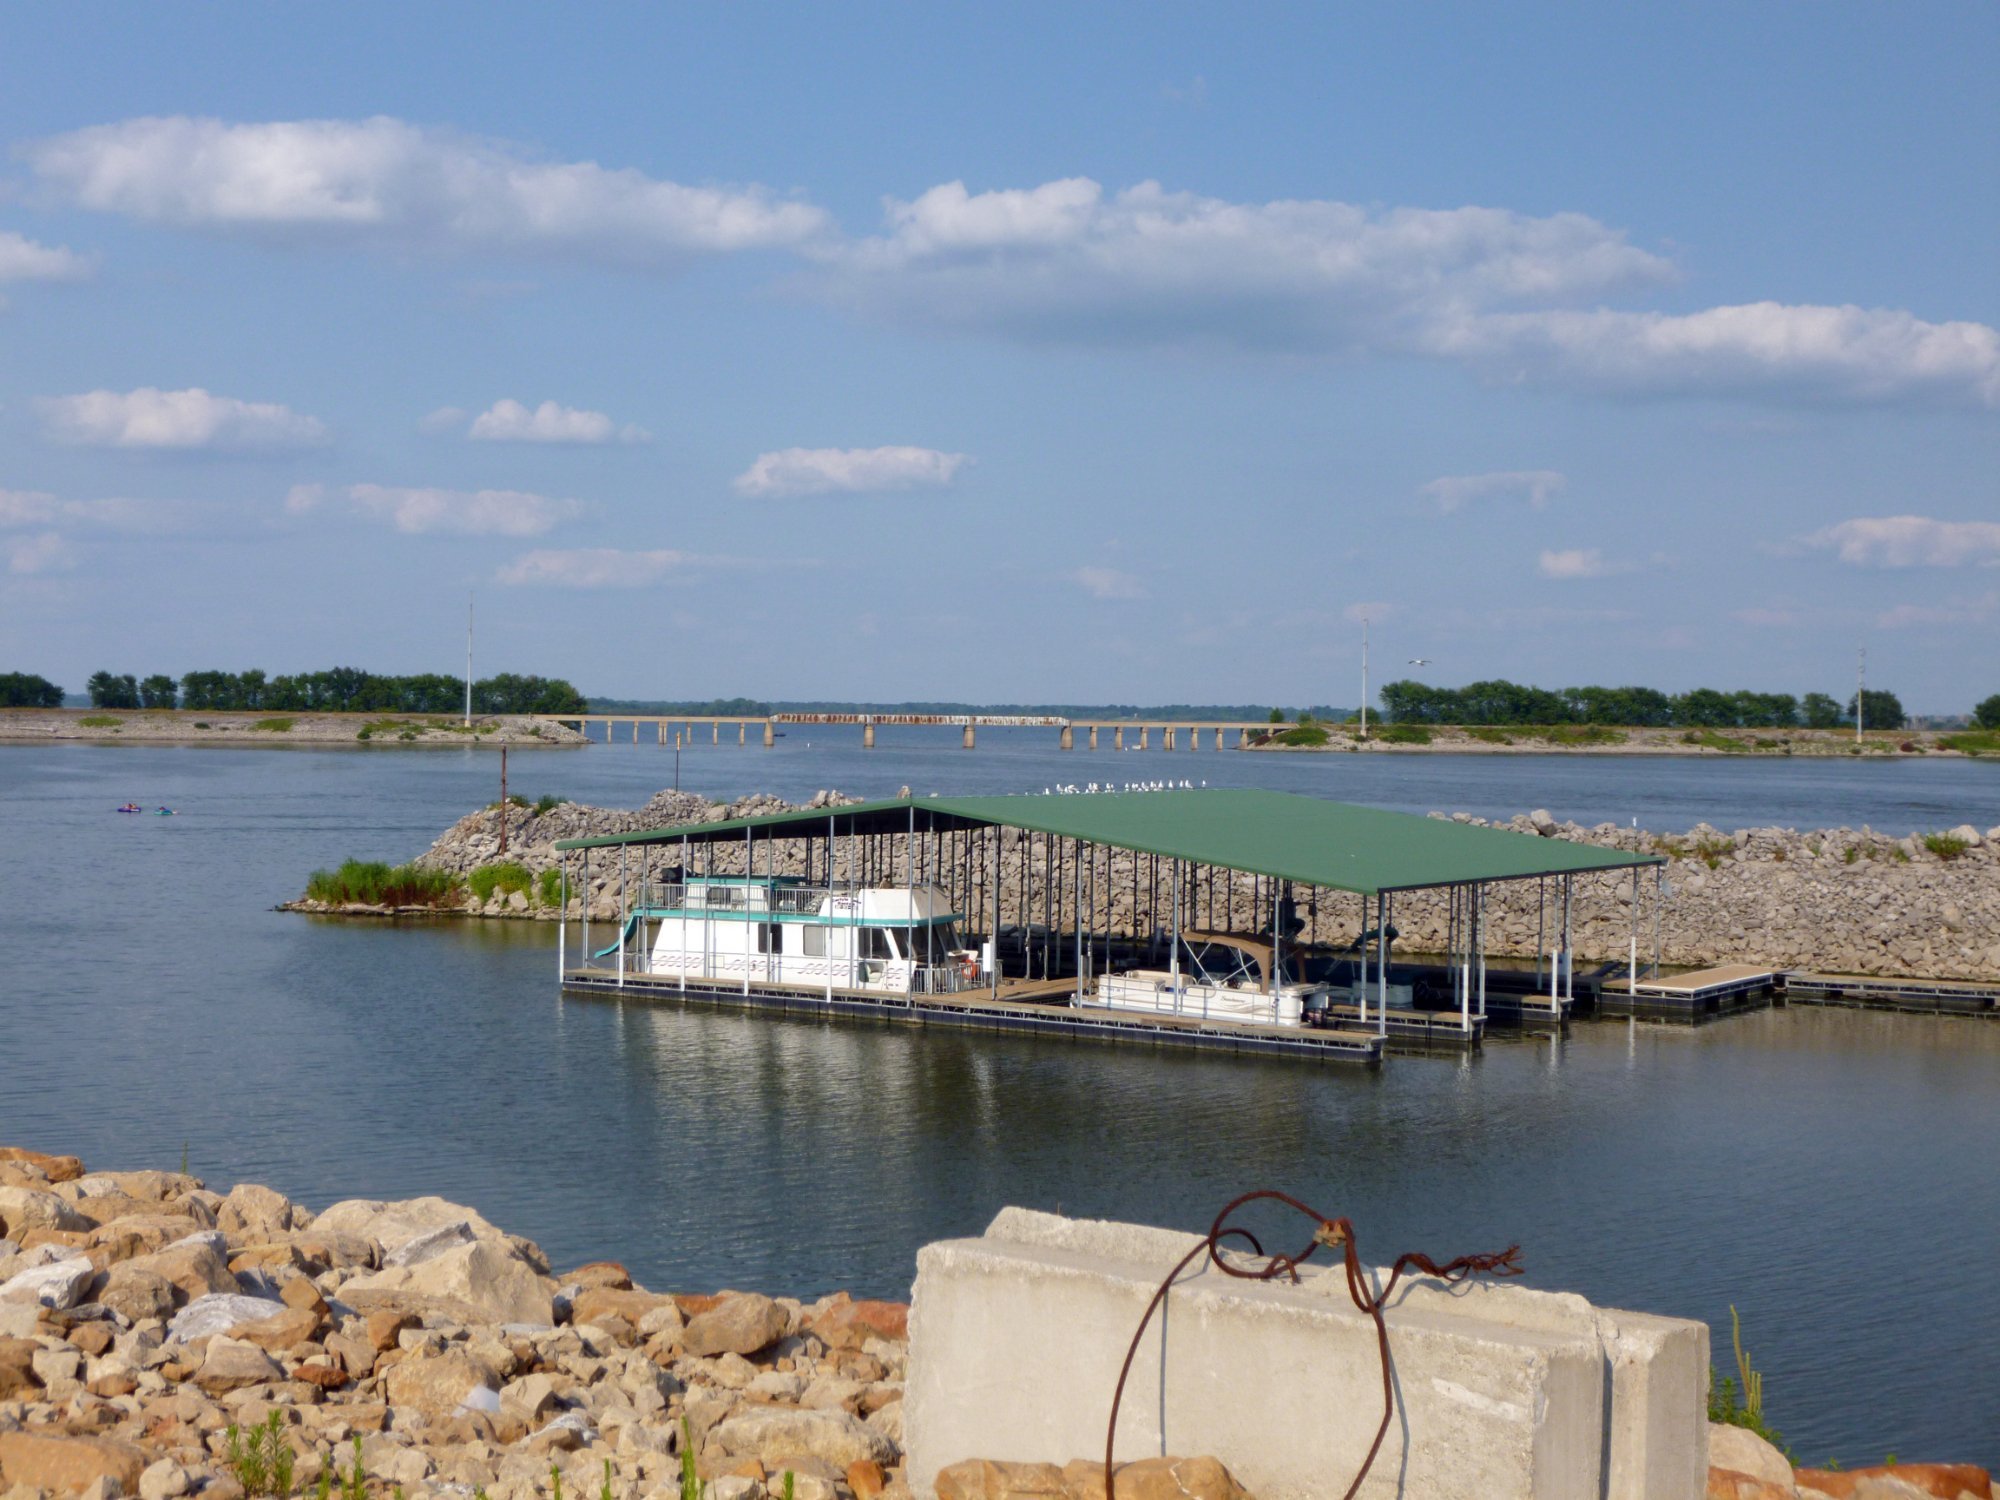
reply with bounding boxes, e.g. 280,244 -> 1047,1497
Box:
0,1148 -> 908,1500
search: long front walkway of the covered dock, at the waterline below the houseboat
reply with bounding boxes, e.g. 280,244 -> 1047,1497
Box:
562,968 -> 1384,1066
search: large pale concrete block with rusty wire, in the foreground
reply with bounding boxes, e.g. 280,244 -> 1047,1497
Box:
904,1208 -> 1708,1500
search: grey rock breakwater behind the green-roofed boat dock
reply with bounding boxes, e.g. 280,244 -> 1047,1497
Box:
296,792 -> 2000,980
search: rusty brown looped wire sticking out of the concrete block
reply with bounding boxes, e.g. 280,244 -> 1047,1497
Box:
1104,1188 -> 1522,1500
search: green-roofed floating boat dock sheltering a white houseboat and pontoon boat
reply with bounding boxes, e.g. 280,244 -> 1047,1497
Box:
558,788 -> 1662,1066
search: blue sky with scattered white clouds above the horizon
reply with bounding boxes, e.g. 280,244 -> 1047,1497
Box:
0,0 -> 2000,712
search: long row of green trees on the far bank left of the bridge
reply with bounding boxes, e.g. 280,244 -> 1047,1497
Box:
70,666 -> 590,714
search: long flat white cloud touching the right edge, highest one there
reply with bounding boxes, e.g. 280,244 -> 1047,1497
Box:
1426,302 -> 2000,406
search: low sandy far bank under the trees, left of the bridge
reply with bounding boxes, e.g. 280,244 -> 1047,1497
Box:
0,708 -> 590,750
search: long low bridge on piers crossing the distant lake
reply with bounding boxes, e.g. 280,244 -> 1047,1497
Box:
534,712 -> 1296,750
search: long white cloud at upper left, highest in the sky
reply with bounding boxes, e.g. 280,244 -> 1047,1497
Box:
20,116 -> 826,266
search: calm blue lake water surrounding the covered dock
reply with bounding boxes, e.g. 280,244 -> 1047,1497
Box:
0,730 -> 2000,1464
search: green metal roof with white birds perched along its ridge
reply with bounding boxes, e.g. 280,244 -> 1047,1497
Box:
556,788 -> 1664,896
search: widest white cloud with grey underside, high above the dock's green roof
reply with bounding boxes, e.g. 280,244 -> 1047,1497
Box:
822,178 -> 1674,352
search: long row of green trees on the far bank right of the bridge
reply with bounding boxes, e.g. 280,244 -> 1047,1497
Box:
1382,678 -> 1904,730
